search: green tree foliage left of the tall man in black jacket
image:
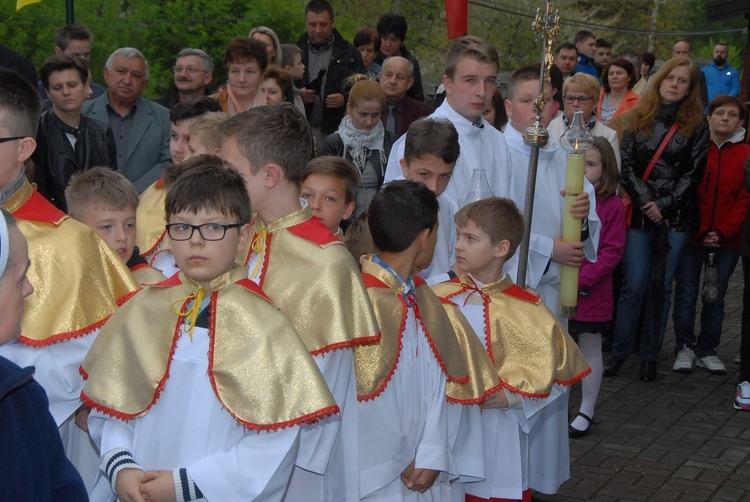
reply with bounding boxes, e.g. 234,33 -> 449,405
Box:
0,0 -> 305,97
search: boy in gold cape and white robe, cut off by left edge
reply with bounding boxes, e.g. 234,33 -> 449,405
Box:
0,66 -> 138,490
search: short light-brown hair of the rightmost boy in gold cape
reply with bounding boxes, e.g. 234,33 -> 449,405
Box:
454,197 -> 524,260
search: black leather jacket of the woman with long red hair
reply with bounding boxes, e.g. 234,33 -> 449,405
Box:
620,109 -> 710,232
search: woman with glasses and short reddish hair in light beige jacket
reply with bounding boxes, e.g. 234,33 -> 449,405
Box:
547,73 -> 620,169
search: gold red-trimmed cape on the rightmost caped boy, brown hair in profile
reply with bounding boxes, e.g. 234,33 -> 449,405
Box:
433,275 -> 591,398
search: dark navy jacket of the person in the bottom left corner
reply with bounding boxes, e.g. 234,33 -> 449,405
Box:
0,357 -> 88,502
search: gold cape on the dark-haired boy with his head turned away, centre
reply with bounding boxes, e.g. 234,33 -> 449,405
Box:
354,256 -> 469,401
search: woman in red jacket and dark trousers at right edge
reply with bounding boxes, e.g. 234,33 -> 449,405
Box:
672,95 -> 750,374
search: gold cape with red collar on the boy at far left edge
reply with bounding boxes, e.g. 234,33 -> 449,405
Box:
3,178 -> 138,347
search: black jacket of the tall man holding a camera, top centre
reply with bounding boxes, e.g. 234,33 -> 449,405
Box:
297,28 -> 366,134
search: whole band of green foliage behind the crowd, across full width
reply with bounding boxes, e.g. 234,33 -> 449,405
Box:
0,0 -> 746,97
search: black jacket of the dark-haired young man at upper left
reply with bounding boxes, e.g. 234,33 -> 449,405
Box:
32,110 -> 117,212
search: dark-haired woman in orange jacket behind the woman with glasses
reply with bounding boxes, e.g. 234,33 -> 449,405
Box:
596,58 -> 639,125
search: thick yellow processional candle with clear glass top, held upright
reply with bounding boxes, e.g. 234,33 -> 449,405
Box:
560,111 -> 594,318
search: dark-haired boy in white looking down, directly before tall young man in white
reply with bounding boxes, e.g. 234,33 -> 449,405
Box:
400,119 -> 461,279
